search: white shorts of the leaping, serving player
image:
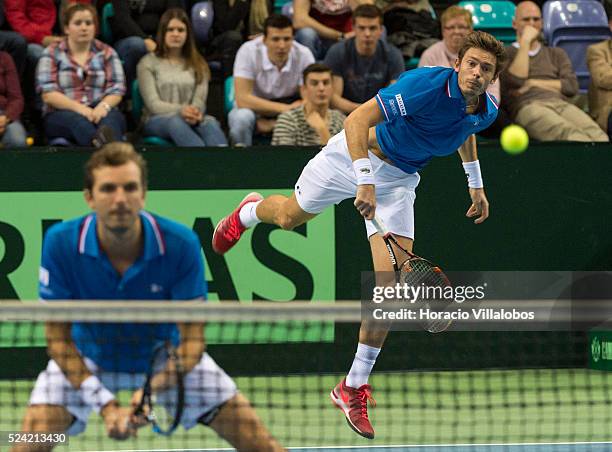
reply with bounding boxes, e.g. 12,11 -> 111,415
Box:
295,130 -> 420,238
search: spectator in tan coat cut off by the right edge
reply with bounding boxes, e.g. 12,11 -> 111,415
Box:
587,1 -> 612,140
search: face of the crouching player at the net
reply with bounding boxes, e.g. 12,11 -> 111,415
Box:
85,162 -> 145,234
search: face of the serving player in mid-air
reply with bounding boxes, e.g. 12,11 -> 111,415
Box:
455,48 -> 497,98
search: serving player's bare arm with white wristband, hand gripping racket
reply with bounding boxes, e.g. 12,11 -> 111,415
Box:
344,99 -> 383,220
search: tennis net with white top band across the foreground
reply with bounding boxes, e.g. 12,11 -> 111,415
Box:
0,301 -> 612,450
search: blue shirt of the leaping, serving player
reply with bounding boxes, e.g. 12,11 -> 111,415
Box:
376,67 -> 498,173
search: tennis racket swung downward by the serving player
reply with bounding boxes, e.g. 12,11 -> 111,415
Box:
372,216 -> 454,333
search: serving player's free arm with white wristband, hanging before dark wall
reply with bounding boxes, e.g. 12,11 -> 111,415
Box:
459,135 -> 489,224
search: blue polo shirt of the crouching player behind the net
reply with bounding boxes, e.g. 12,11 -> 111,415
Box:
39,211 -> 206,372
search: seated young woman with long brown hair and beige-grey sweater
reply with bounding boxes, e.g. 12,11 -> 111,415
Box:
138,8 -> 227,147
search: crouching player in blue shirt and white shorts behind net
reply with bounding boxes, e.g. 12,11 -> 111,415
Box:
15,142 -> 284,452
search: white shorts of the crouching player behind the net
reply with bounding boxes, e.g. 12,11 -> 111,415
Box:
30,353 -> 237,435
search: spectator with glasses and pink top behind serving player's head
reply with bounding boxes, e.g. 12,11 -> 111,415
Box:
419,5 -> 500,101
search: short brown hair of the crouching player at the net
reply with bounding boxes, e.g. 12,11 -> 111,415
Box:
85,141 -> 148,191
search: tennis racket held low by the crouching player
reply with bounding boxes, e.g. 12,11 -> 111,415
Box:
134,343 -> 185,436
